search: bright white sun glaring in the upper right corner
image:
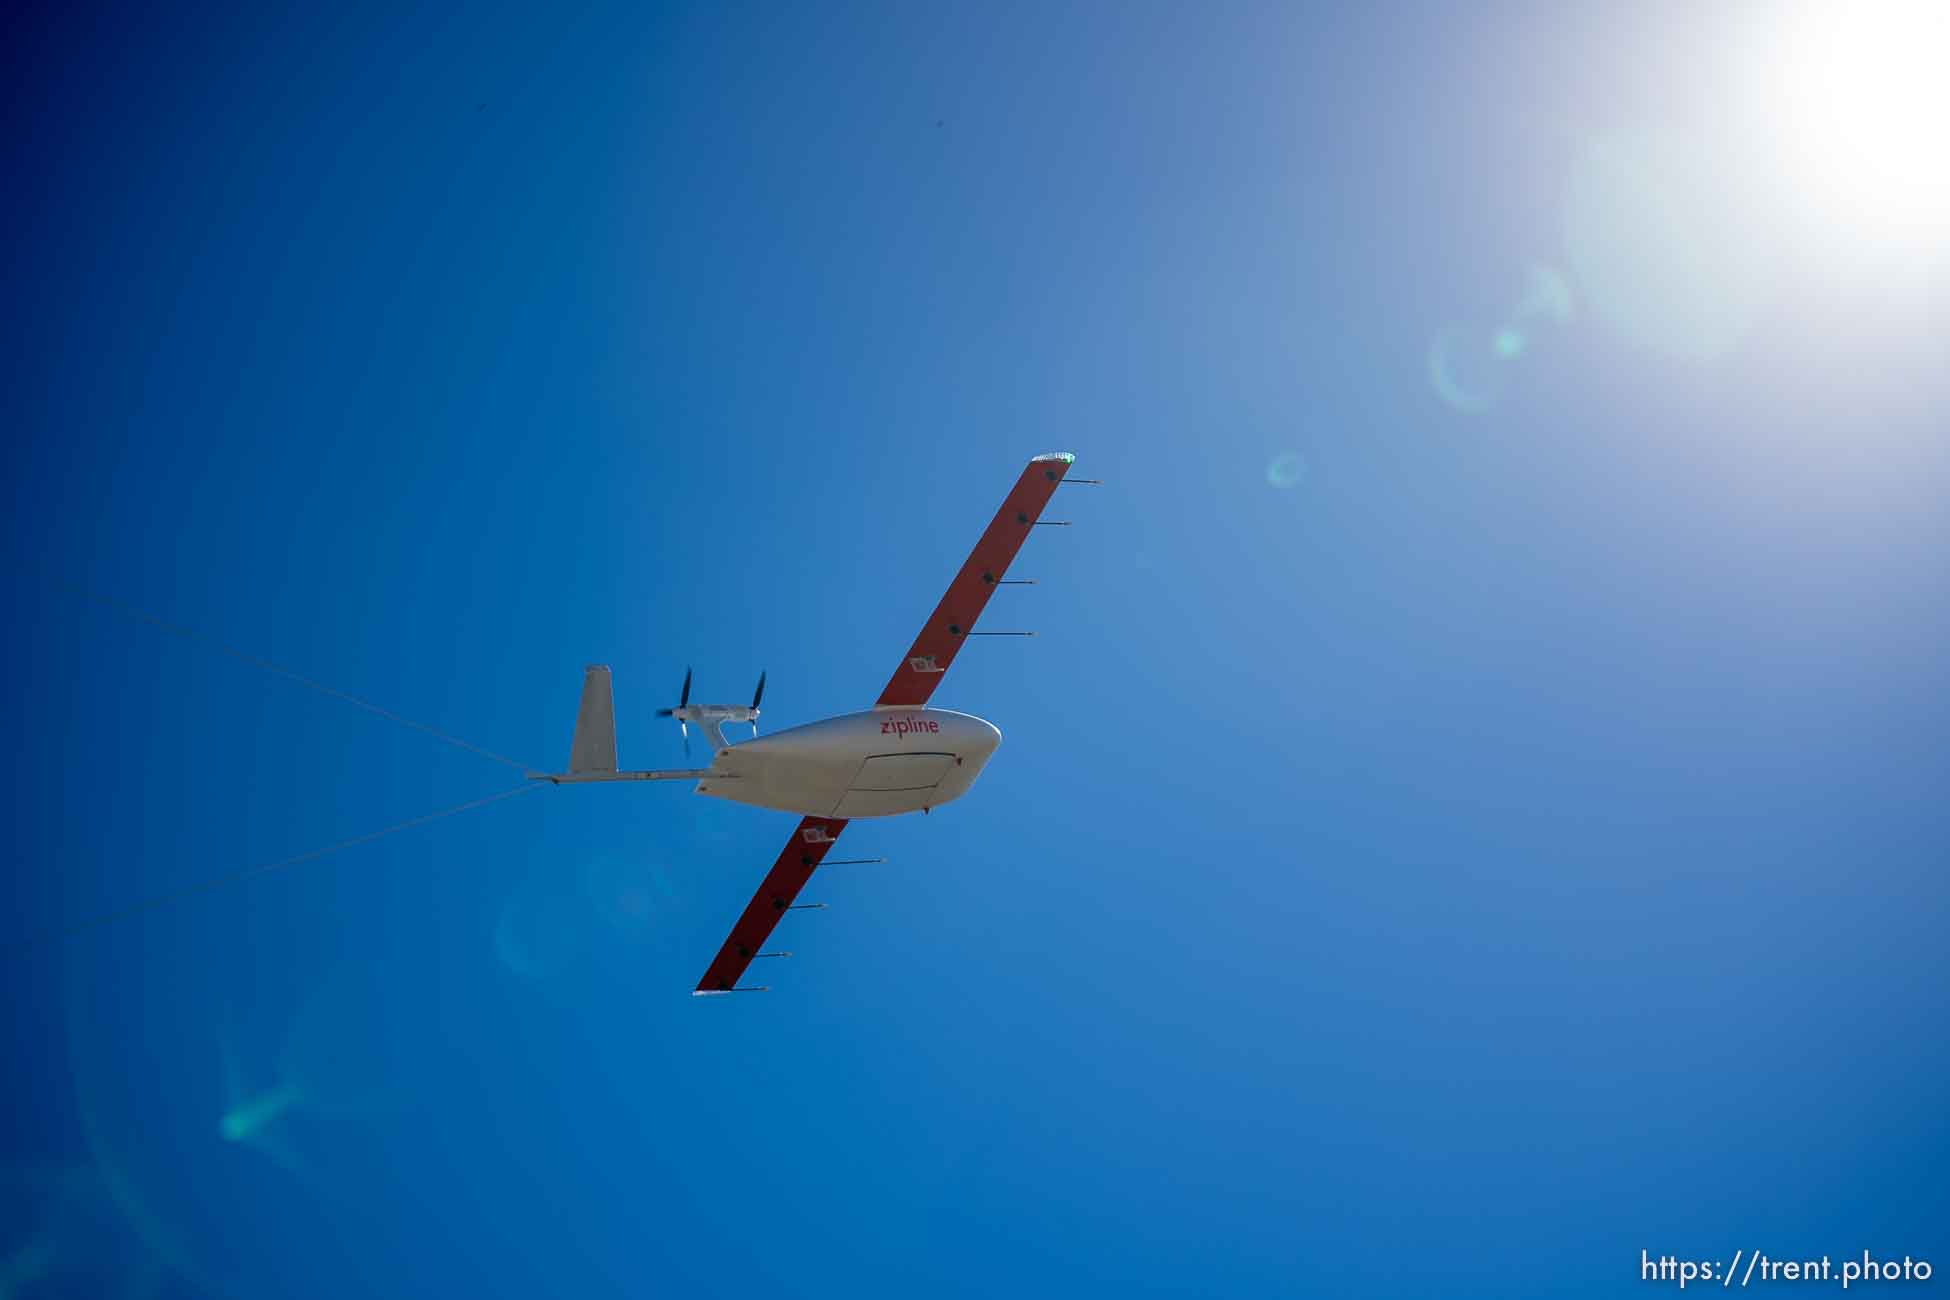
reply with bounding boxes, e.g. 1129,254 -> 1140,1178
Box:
1757,0 -> 1950,248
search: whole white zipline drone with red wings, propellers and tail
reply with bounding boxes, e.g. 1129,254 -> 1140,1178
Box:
528,452 -> 1096,998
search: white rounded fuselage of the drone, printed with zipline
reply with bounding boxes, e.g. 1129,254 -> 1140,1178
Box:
696,709 -> 1002,817
